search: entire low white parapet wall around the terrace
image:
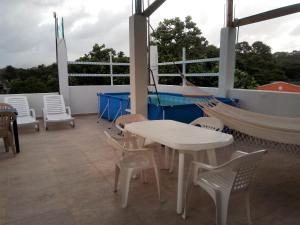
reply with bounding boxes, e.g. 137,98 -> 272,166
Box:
0,85 -> 300,118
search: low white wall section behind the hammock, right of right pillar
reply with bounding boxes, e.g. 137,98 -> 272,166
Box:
229,89 -> 300,118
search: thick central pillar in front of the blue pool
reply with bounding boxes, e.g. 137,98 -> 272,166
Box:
129,15 -> 149,117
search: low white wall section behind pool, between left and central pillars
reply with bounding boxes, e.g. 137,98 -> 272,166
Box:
69,85 -> 130,114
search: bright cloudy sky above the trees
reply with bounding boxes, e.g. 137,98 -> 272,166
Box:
0,0 -> 300,68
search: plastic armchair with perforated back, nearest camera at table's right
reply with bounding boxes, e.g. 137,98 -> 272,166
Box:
183,150 -> 266,225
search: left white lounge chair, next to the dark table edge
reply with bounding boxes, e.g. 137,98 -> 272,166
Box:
4,96 -> 39,131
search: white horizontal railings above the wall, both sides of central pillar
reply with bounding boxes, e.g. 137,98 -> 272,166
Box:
67,48 -> 220,86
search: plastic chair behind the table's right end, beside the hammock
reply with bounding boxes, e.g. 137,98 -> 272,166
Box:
169,117 -> 224,173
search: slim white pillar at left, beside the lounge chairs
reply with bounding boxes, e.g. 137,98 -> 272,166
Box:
57,38 -> 70,105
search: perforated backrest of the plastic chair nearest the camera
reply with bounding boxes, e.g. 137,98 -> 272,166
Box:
227,150 -> 267,192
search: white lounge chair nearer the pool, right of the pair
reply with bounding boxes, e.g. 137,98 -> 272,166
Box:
43,95 -> 75,130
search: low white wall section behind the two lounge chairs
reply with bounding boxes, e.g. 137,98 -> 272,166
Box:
0,93 -> 57,117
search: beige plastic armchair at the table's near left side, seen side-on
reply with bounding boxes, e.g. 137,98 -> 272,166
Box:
104,131 -> 161,208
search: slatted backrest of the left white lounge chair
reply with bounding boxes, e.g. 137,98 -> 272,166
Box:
4,96 -> 30,116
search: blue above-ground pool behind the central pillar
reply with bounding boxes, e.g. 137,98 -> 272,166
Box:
97,92 -> 236,123
